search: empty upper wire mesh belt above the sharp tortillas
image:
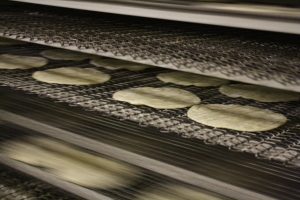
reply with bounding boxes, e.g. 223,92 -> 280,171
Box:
0,2 -> 300,91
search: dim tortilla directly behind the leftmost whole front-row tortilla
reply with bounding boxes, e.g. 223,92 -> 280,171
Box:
41,49 -> 91,61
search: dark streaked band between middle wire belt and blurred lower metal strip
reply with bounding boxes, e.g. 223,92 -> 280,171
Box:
2,90 -> 300,199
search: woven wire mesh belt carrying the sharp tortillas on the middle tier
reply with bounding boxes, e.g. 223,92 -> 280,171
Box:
0,46 -> 300,167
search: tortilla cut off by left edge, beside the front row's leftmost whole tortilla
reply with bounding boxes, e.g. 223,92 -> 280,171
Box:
0,54 -> 48,69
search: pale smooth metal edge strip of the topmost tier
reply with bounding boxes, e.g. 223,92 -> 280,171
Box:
9,0 -> 300,34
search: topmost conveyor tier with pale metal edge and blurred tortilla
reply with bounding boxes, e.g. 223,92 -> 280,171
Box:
9,0 -> 300,34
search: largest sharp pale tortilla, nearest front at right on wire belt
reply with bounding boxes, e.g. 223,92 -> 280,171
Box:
187,104 -> 287,132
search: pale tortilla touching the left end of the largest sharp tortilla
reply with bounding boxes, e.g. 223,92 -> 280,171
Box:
113,87 -> 200,109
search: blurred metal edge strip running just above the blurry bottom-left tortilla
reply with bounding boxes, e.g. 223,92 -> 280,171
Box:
0,109 -> 275,200
